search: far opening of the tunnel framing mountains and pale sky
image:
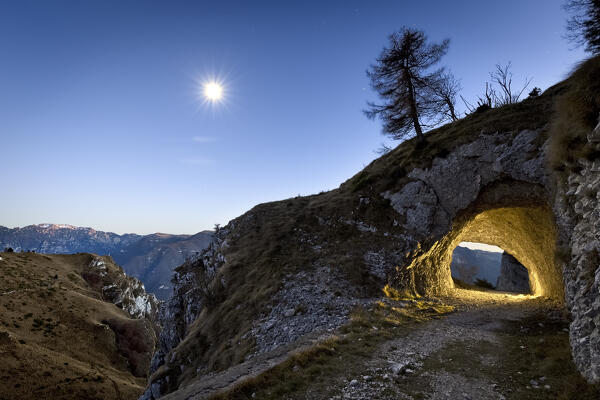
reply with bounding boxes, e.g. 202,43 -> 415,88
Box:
450,242 -> 531,294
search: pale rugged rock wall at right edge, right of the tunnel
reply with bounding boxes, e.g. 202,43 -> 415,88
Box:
555,124 -> 600,382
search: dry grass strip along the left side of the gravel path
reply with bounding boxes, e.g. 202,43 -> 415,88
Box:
211,300 -> 453,400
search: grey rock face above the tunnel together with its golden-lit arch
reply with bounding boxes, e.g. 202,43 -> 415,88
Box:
382,131 -> 564,301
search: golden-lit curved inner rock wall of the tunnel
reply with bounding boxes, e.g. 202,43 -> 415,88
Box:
406,202 -> 564,303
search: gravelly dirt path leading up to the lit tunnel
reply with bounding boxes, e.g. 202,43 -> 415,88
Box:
332,301 -> 551,399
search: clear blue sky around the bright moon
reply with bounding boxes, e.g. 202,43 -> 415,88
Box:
0,0 -> 585,233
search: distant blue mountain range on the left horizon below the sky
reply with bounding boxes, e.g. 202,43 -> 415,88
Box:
0,224 -> 213,299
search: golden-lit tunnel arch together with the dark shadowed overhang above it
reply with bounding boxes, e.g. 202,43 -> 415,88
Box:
390,180 -> 564,304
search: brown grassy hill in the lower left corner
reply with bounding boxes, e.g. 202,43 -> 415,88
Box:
0,253 -> 146,399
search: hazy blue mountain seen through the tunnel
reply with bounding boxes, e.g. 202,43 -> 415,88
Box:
450,246 -> 503,285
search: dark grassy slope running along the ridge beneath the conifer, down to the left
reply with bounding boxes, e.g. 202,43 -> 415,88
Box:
155,57 -> 600,394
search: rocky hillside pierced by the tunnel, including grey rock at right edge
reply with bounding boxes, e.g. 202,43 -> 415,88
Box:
139,62 -> 600,399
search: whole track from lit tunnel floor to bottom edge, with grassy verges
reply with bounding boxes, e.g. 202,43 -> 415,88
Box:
165,291 -> 600,400
